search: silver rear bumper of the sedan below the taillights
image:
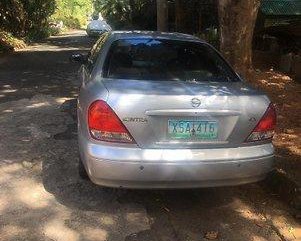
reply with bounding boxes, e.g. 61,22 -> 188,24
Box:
79,138 -> 274,188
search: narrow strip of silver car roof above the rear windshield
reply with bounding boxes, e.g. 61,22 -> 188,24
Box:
111,30 -> 205,43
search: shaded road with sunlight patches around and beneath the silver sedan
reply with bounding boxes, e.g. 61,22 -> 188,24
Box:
0,32 -> 301,241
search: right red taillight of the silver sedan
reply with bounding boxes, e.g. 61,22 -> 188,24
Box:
246,104 -> 276,142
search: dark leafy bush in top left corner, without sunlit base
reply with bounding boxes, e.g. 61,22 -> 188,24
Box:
0,0 -> 55,38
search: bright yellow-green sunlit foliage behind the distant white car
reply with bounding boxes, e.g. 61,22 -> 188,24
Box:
51,0 -> 93,28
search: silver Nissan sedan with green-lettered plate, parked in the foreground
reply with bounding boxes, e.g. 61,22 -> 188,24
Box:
73,31 -> 276,188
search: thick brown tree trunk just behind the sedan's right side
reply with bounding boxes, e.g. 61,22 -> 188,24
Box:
218,0 -> 260,76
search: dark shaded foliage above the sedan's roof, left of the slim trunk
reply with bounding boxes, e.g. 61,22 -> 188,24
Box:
94,0 -> 156,30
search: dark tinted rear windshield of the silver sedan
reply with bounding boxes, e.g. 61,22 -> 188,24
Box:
104,38 -> 239,82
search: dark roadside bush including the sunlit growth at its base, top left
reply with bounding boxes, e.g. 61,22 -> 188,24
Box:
0,0 -> 55,51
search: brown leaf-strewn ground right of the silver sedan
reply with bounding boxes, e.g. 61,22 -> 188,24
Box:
253,70 -> 301,187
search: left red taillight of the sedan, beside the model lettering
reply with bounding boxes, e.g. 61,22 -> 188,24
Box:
88,100 -> 135,143
